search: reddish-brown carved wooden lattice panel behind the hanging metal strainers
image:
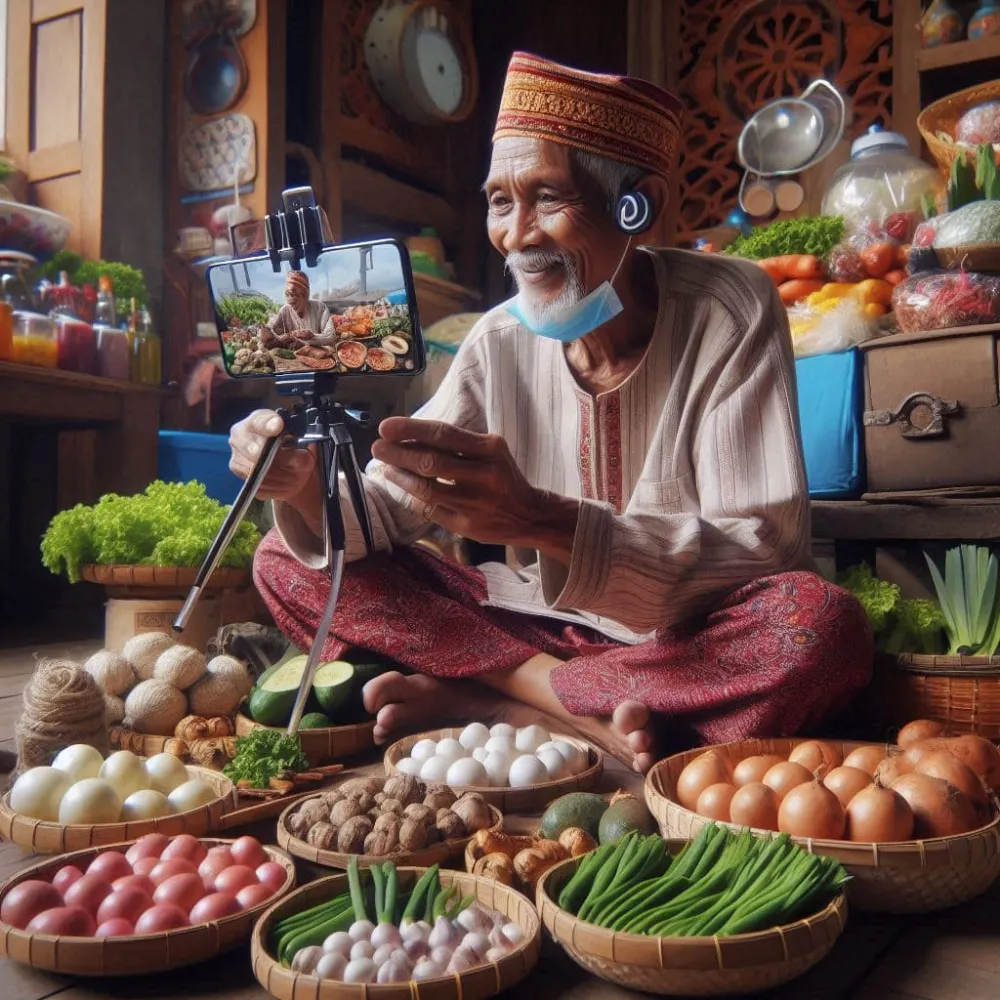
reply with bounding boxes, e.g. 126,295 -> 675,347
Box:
677,0 -> 892,239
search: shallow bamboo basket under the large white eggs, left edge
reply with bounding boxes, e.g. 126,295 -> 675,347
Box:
0,765 -> 236,854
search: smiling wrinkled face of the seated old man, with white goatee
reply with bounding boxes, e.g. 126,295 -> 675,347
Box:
486,137 -> 626,321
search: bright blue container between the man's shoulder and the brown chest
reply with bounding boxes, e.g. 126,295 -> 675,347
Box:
795,347 -> 865,500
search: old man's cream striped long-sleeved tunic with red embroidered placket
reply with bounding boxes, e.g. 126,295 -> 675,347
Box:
275,249 -> 809,643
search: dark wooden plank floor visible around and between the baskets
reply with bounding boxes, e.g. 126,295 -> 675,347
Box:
0,642 -> 1000,1000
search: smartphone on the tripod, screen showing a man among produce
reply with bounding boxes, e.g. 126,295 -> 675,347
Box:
206,240 -> 426,379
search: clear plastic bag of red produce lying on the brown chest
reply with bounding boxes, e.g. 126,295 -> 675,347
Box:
892,271 -> 1000,333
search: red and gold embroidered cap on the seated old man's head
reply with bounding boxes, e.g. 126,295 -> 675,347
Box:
493,52 -> 682,179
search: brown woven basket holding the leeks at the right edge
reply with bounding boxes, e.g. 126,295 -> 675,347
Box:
871,653 -> 1000,740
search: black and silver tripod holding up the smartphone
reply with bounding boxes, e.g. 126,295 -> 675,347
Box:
173,372 -> 375,736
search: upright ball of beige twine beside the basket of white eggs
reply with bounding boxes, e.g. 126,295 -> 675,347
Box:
13,658 -> 109,778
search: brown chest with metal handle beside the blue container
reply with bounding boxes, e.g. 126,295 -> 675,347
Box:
862,325 -> 1000,493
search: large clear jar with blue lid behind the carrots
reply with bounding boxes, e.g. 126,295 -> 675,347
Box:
822,125 -> 943,243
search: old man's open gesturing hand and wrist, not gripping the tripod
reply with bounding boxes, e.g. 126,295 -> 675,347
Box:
372,417 -> 578,563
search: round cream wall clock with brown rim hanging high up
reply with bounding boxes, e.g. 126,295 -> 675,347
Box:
364,0 -> 479,125
